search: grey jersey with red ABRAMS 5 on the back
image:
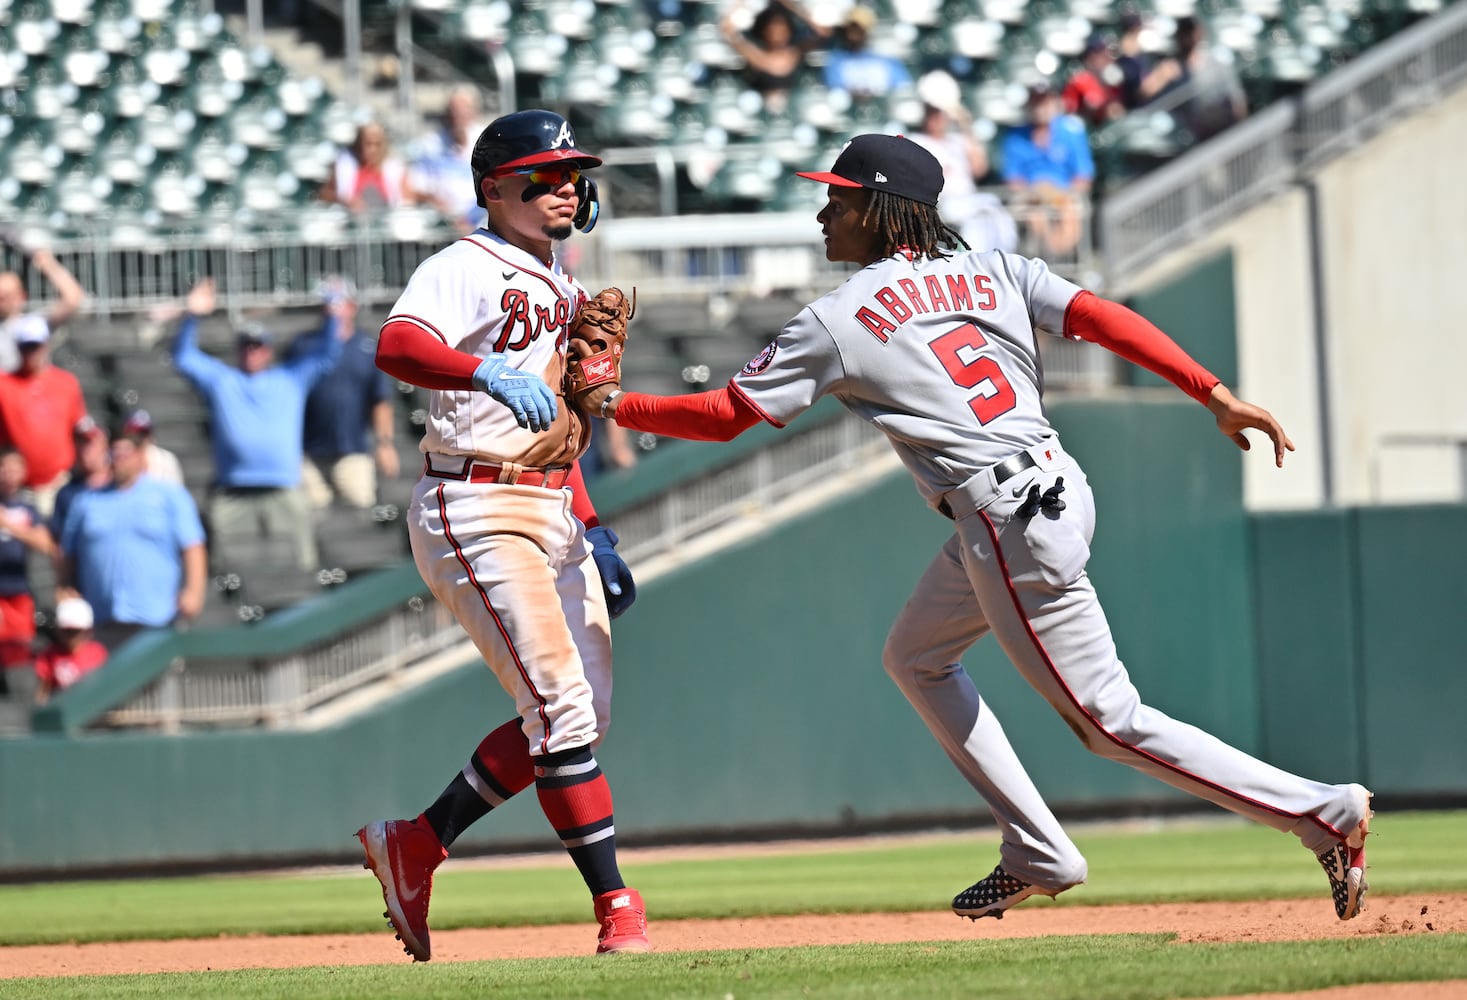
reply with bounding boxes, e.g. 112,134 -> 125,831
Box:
731,251 -> 1083,501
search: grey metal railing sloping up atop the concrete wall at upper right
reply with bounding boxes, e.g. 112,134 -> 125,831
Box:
1100,3 -> 1467,287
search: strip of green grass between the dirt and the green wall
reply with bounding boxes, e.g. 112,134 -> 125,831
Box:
0,812 -> 1467,944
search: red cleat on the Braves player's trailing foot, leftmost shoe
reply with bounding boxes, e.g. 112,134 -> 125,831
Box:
356,817 -> 449,962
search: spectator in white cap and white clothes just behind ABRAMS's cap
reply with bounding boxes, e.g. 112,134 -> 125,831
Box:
910,70 -> 1018,251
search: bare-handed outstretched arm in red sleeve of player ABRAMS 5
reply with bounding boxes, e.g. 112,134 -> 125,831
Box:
1065,292 -> 1294,468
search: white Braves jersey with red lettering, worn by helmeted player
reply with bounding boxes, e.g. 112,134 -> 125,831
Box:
387,229 -> 588,468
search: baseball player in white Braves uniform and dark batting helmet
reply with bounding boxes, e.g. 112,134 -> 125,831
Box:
356,110 -> 650,962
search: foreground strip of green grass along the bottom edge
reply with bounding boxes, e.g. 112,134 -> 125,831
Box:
0,934 -> 1467,1000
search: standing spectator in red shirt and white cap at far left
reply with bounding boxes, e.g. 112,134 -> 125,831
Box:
0,314 -> 87,516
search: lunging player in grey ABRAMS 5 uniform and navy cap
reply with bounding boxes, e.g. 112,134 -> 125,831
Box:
588,135 -> 1370,919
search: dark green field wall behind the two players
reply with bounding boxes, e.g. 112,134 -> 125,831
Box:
0,384 -> 1467,878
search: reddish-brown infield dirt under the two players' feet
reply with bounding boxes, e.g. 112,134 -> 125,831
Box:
0,893 -> 1467,979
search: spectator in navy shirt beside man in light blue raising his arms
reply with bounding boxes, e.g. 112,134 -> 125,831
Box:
286,276 -> 398,507
